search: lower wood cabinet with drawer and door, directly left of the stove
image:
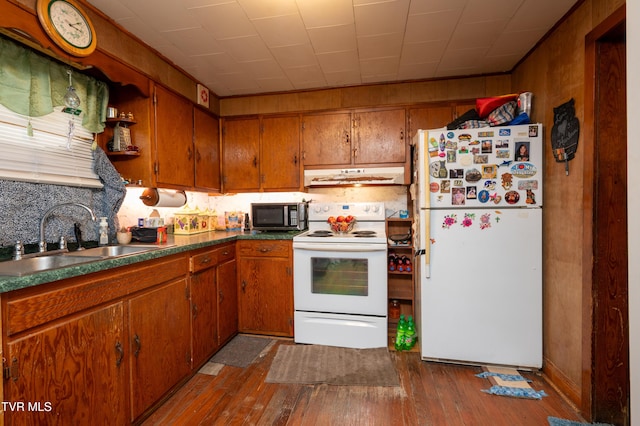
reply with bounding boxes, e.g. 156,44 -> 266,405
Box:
236,240 -> 293,337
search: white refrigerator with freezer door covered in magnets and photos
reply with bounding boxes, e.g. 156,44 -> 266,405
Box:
411,124 -> 543,369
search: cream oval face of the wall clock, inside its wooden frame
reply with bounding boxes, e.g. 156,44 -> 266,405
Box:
49,0 -> 93,49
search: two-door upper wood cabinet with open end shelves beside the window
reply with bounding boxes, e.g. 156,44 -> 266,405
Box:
101,85 -> 221,192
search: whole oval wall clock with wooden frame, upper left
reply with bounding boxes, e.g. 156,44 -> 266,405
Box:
36,0 -> 97,57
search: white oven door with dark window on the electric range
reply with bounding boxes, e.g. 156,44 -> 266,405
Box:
293,241 -> 387,317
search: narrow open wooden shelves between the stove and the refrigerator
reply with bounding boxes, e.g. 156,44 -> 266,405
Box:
386,218 -> 416,346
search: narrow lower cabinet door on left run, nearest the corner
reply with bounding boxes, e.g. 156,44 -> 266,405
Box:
217,259 -> 238,346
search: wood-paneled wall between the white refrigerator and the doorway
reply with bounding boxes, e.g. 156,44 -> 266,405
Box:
512,0 -> 625,414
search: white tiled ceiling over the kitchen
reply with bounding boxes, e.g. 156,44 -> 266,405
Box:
88,0 -> 578,97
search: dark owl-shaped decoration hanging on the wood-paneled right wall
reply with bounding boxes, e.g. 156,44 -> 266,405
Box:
551,98 -> 580,176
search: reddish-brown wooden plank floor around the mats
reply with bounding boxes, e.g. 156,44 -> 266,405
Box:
143,339 -> 582,426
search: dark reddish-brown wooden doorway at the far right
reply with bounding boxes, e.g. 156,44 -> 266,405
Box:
582,6 -> 630,425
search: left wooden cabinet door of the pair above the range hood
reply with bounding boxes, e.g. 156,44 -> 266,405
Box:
302,112 -> 351,166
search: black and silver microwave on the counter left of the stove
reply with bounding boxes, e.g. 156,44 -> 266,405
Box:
251,203 -> 308,231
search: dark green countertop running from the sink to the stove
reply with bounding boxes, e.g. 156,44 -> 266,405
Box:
0,231 -> 300,293
